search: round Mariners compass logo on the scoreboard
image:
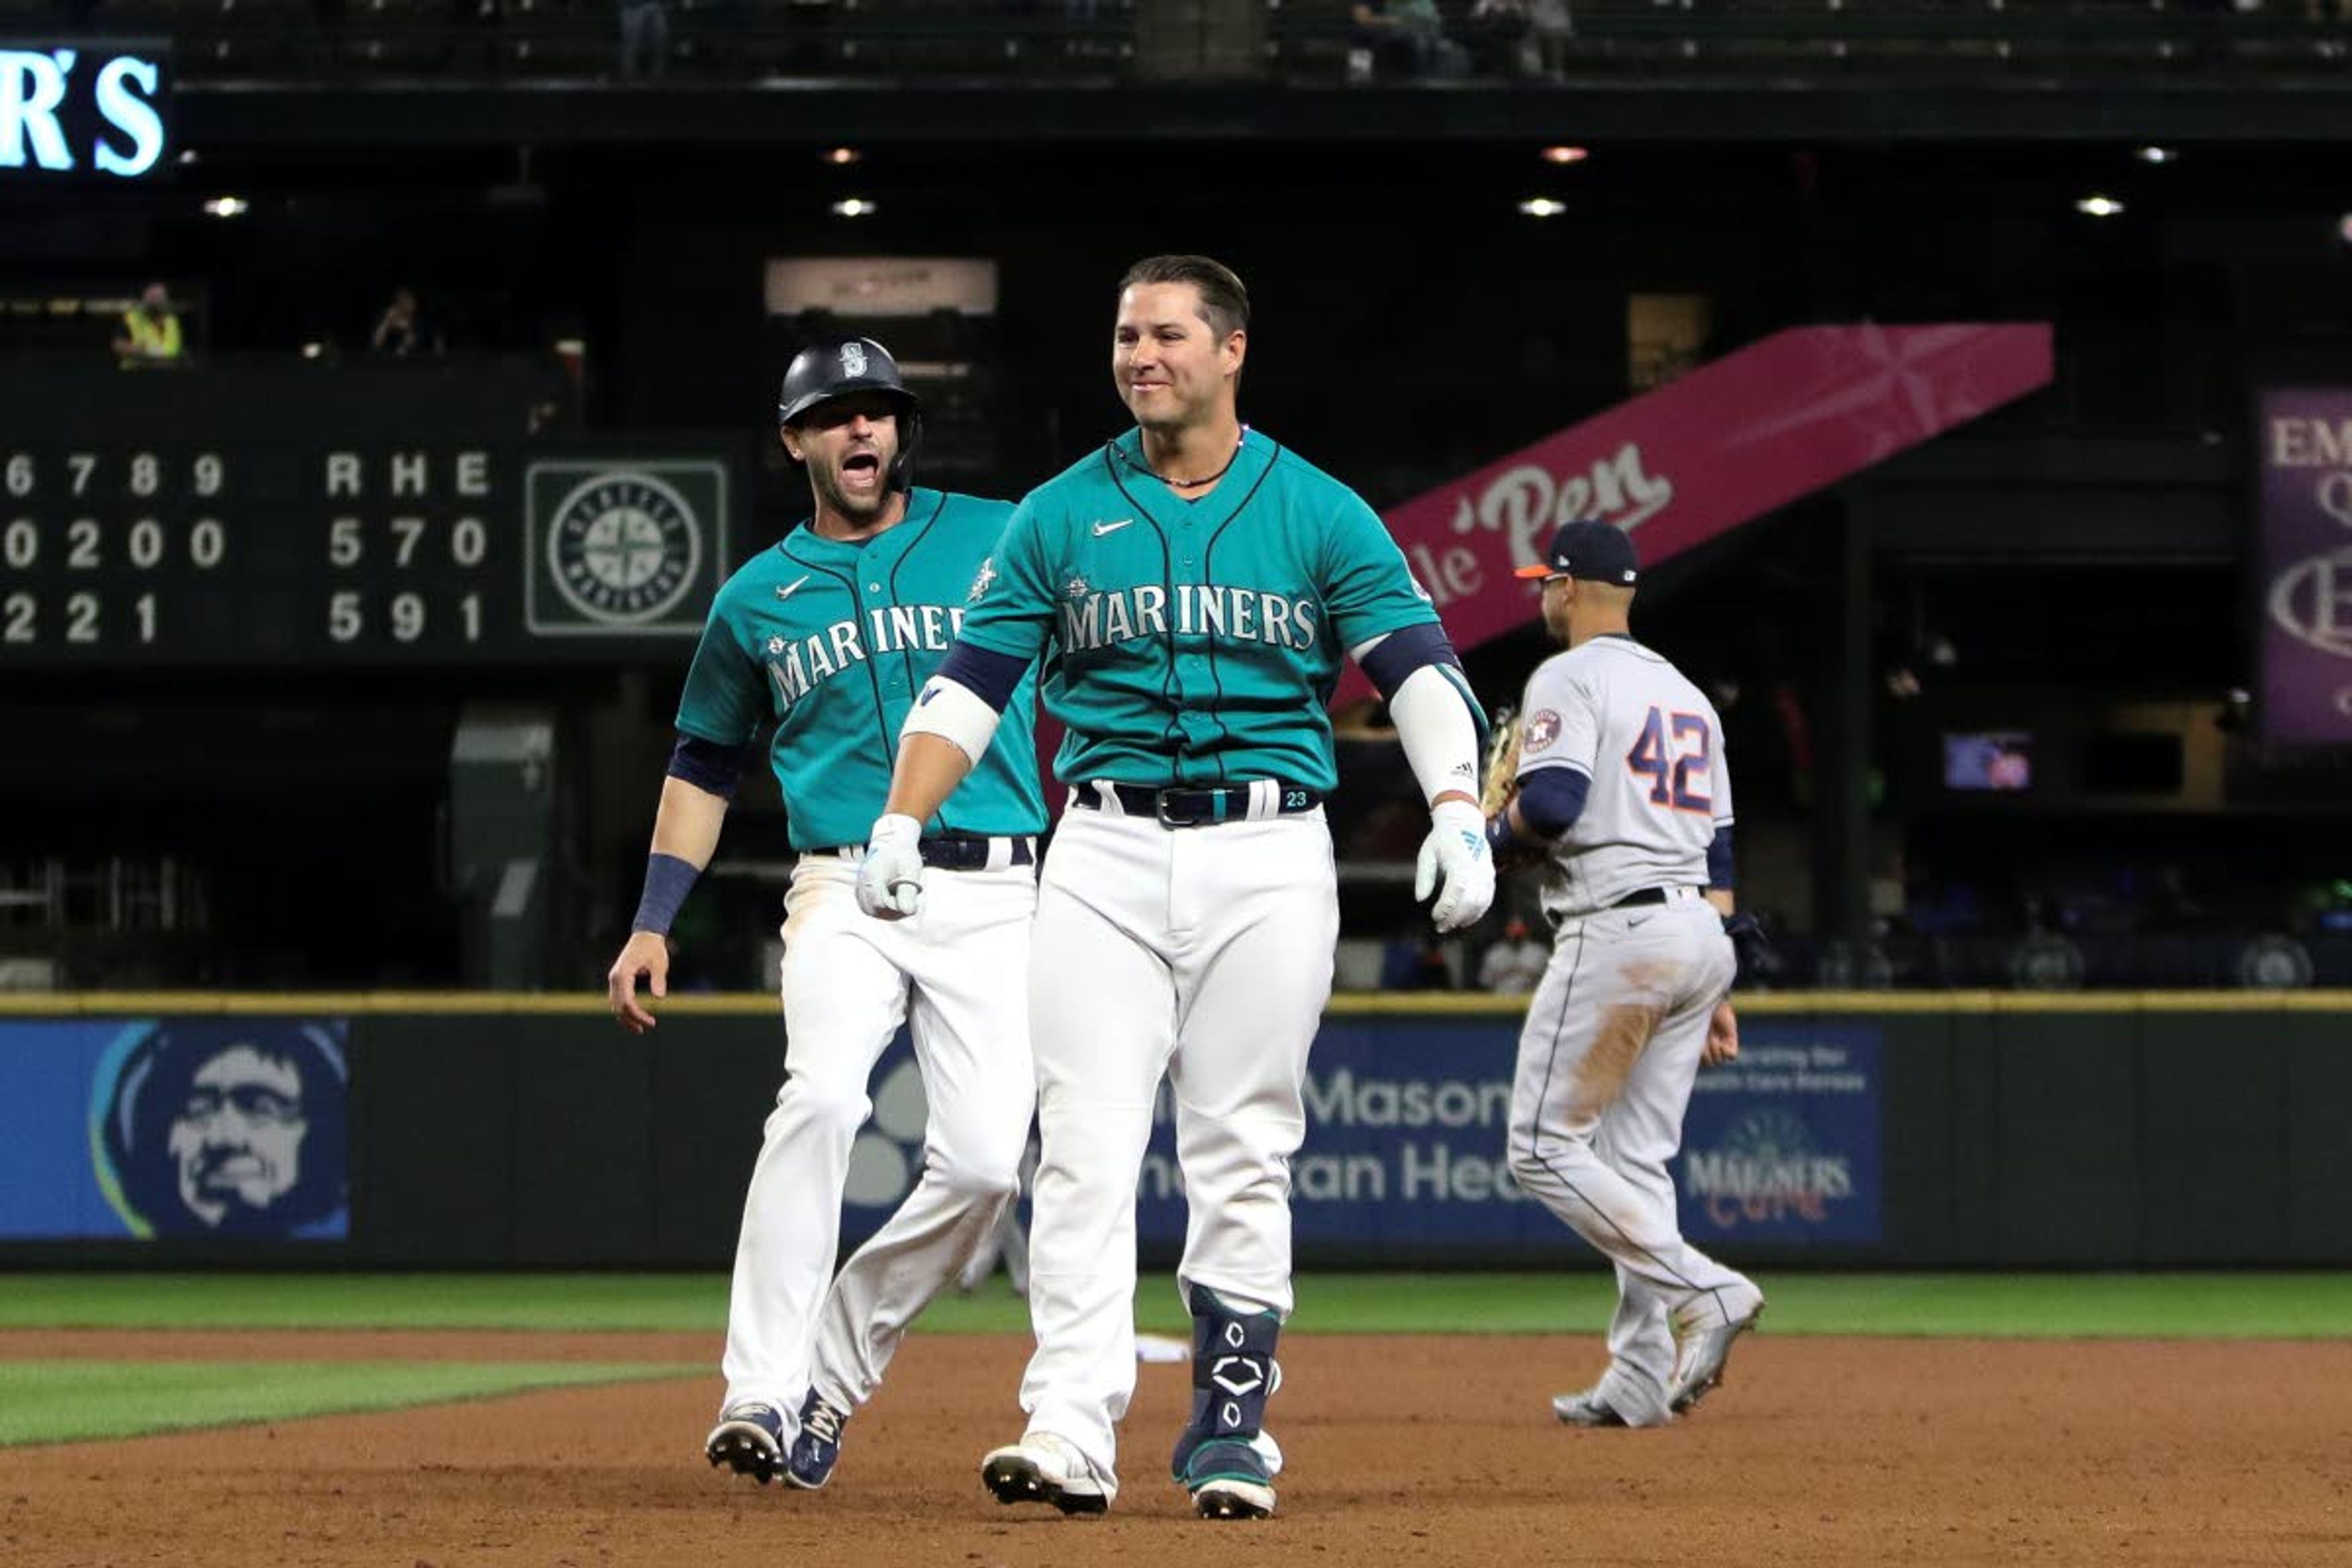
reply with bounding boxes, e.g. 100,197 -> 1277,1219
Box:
546,470 -> 703,625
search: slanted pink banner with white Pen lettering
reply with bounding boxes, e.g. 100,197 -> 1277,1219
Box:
1343,322 -> 2051,696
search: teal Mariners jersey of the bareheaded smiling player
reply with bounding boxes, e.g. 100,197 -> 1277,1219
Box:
964,430 -> 1437,790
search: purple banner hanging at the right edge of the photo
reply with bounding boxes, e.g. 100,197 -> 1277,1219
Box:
2256,385 -> 2352,745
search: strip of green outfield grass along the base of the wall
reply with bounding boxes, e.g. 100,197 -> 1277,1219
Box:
0,1267 -> 2352,1357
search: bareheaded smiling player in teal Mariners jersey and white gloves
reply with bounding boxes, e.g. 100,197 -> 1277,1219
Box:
859,256 -> 1493,1518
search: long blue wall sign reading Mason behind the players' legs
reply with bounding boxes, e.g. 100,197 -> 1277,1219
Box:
842,1018 -> 1882,1262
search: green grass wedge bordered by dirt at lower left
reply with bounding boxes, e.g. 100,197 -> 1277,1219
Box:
0,1361 -> 701,1446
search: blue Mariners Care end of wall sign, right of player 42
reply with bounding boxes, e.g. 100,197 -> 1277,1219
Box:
1675,1025 -> 1884,1248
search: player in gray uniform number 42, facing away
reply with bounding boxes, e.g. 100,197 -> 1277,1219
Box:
1489,522 -> 1764,1427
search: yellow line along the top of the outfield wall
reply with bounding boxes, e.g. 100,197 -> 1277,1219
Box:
0,990 -> 2352,1018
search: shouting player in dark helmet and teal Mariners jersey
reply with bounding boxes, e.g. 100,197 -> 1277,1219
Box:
607,339 -> 1044,1488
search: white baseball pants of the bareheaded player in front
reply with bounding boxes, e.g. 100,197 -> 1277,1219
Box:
1021,809 -> 1338,1495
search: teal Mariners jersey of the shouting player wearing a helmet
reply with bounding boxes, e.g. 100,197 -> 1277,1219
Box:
677,489 -> 1044,849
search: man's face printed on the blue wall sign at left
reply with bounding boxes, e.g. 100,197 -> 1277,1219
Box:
165,1044 -> 311,1225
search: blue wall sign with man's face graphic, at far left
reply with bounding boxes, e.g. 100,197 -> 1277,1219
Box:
0,1018 -> 350,1242
